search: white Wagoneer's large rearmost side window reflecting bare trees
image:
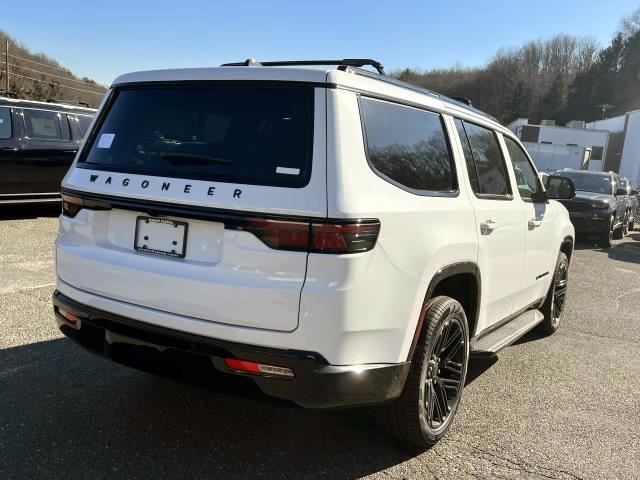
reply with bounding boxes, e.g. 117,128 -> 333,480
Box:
360,98 -> 457,192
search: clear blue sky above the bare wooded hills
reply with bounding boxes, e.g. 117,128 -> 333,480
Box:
0,0 -> 640,85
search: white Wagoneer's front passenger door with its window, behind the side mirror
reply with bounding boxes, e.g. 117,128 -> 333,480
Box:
502,136 -> 558,308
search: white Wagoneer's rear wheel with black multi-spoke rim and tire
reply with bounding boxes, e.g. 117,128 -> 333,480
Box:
376,296 -> 469,449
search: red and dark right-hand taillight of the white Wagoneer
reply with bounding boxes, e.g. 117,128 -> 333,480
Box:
242,219 -> 380,254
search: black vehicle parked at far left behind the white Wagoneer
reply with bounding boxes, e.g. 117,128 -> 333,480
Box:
0,97 -> 96,204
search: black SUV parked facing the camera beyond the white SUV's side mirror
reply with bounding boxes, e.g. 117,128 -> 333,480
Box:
549,170 -> 628,247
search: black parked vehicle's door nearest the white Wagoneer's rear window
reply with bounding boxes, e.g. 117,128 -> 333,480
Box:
20,108 -> 78,194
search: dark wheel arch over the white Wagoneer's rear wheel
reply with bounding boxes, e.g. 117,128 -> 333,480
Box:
407,262 -> 482,360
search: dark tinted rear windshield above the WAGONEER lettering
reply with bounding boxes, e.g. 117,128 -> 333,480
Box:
78,85 -> 313,187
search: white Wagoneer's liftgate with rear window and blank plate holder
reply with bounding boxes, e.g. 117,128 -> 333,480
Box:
57,82 -> 327,331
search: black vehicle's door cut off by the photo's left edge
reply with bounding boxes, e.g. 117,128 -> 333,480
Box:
0,106 -> 22,195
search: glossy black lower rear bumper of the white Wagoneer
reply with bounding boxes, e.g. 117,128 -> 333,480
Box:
53,290 -> 410,408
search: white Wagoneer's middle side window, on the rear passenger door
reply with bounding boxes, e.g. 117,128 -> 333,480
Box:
456,120 -> 511,198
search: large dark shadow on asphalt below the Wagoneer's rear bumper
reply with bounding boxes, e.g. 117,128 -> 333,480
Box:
0,339 -> 420,479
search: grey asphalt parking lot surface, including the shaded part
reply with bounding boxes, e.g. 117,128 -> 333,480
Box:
0,208 -> 640,479
